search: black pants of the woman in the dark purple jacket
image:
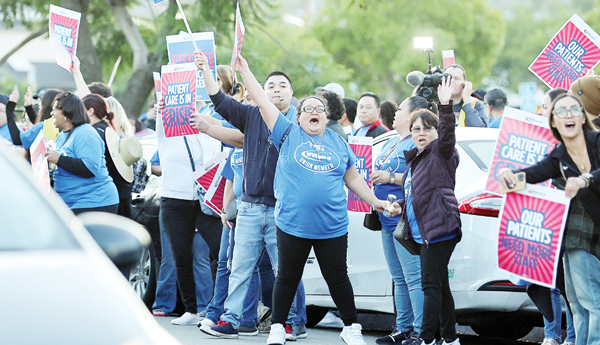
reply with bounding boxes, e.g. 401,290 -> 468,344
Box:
419,237 -> 458,344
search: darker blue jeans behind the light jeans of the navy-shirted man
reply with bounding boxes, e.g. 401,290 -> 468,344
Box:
206,225 -> 259,326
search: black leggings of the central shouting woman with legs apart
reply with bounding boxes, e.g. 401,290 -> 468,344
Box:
273,228 -> 357,326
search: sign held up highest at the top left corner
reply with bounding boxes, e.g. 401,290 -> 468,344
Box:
49,5 -> 81,72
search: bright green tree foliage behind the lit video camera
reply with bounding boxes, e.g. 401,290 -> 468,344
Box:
313,0 -> 505,102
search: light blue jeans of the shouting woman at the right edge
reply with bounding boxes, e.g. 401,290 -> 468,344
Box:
563,249 -> 600,345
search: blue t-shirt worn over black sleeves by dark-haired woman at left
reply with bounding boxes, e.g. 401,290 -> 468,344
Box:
53,123 -> 119,209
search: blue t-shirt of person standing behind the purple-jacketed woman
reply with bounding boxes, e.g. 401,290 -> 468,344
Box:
374,136 -> 415,230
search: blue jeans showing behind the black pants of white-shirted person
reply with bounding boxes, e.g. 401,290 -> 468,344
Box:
152,219 -> 213,315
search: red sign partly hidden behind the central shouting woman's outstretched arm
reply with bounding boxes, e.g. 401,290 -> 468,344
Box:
348,136 -> 373,213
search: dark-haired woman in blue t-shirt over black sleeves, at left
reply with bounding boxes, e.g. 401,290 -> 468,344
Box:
46,92 -> 119,214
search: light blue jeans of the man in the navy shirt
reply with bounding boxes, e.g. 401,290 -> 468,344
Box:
221,202 -> 277,329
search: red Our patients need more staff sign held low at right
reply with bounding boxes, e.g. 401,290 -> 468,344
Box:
498,185 -> 570,288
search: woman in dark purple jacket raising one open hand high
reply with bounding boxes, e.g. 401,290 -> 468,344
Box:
400,78 -> 462,345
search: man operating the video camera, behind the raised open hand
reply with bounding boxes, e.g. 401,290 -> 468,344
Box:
444,65 -> 488,127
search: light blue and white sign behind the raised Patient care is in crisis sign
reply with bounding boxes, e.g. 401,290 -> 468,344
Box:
167,32 -> 217,101
